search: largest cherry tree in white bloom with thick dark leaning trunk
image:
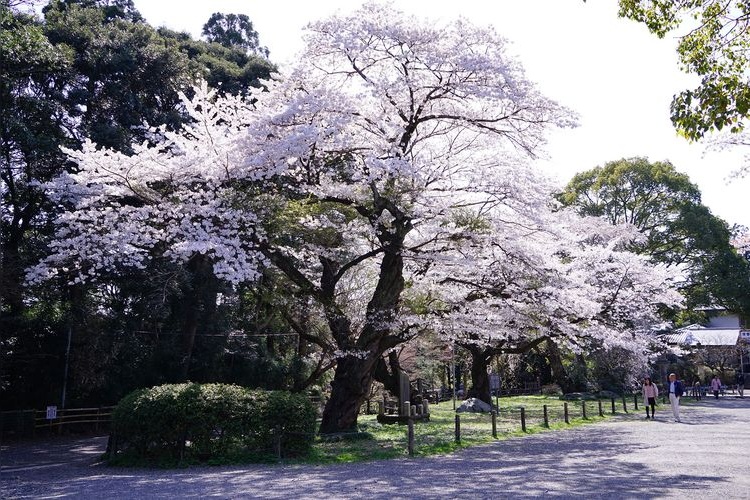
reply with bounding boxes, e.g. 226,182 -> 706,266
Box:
30,4 -> 574,433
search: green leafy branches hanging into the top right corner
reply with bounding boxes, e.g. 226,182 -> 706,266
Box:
620,0 -> 750,140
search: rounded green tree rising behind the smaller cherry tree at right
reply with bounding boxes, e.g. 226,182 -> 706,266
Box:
558,158 -> 750,312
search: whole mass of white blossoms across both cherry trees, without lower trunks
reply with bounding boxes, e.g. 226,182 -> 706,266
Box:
29,3 -> 677,368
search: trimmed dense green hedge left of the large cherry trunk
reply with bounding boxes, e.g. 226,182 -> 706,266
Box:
109,383 -> 316,461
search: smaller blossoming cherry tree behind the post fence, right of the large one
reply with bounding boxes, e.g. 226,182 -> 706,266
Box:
424,194 -> 681,403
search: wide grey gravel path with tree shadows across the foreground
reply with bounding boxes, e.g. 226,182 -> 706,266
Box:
0,397 -> 750,500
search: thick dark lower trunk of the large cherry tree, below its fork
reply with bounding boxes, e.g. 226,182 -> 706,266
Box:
320,356 -> 375,434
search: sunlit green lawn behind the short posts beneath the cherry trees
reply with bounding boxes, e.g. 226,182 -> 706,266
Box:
304,396 -> 616,464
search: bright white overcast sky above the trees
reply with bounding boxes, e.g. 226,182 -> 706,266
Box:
135,0 -> 750,226
